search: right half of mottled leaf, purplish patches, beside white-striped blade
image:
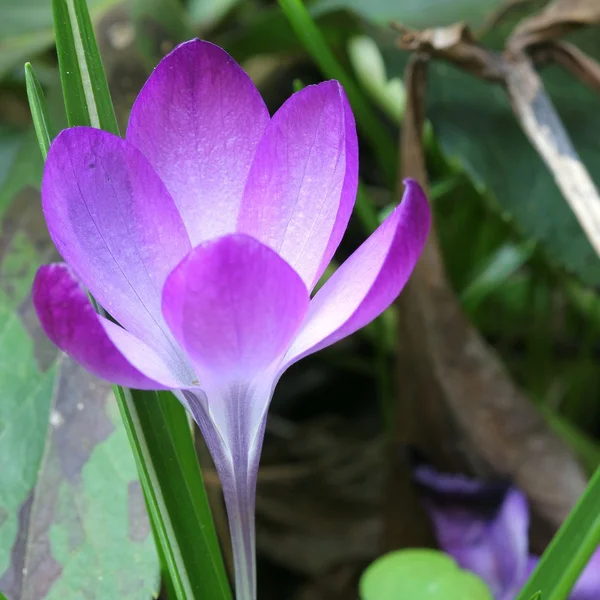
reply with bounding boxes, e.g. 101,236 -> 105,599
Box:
21,357 -> 158,600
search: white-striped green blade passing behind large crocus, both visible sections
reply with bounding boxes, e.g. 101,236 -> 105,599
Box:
48,0 -> 231,600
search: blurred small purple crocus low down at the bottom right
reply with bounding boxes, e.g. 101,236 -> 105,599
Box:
416,467 -> 600,600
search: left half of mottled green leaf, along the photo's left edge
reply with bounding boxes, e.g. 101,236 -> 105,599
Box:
0,191 -> 56,600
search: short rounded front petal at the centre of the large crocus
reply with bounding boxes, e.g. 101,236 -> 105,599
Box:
163,234 -> 309,382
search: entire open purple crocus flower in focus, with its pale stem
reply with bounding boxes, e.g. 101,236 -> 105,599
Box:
33,40 -> 430,600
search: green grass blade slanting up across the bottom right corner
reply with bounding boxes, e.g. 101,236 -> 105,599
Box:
517,469 -> 600,600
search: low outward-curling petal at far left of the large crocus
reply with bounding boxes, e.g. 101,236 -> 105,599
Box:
33,264 -> 182,390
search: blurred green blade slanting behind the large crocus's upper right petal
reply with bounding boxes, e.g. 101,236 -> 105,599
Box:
279,0 -> 397,187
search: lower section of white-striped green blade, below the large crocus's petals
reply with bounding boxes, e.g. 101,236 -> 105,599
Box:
115,388 -> 231,600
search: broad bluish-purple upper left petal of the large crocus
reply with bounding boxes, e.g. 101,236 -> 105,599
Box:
42,127 -> 190,368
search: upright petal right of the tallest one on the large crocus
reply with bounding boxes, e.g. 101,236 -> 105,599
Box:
238,81 -> 358,289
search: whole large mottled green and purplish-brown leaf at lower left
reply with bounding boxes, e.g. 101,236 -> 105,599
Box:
0,188 -> 158,600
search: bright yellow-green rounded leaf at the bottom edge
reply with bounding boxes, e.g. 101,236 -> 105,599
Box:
360,549 -> 492,600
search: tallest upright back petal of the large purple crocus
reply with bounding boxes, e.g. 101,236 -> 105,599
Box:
127,40 -> 269,246
